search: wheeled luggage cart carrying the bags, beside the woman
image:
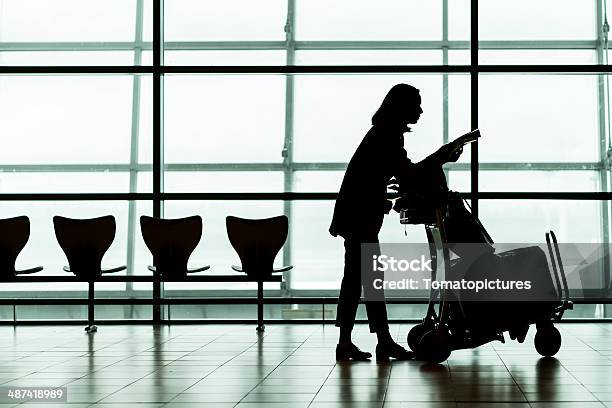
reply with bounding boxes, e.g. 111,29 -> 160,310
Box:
400,204 -> 573,363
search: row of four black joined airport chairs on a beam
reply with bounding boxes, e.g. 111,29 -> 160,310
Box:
0,215 -> 292,333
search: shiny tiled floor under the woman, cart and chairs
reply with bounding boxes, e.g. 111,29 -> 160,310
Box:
0,324 -> 612,408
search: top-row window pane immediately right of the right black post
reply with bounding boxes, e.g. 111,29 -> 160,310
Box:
478,0 -> 597,40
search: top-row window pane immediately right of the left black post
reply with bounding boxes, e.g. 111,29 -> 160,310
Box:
164,0 -> 287,41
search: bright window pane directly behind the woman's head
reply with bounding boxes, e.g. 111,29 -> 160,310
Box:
294,75 -> 469,163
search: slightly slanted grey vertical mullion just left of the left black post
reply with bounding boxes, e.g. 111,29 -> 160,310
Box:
125,0 -> 144,300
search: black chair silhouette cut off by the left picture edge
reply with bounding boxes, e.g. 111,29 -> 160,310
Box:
0,215 -> 43,280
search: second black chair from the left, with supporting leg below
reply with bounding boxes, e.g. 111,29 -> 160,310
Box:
53,215 -> 126,333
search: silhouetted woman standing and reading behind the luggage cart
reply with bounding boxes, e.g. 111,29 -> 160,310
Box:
329,84 -> 462,361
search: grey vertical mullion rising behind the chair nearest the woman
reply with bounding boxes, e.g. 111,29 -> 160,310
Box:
281,0 -> 295,296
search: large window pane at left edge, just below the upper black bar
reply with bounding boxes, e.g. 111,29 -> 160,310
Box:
0,75 -> 151,164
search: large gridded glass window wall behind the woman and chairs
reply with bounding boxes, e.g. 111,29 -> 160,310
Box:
0,0 -> 612,318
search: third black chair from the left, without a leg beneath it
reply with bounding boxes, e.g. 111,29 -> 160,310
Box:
140,215 -> 210,280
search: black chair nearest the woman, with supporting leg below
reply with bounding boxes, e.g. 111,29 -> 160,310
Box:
225,215 -> 293,331
